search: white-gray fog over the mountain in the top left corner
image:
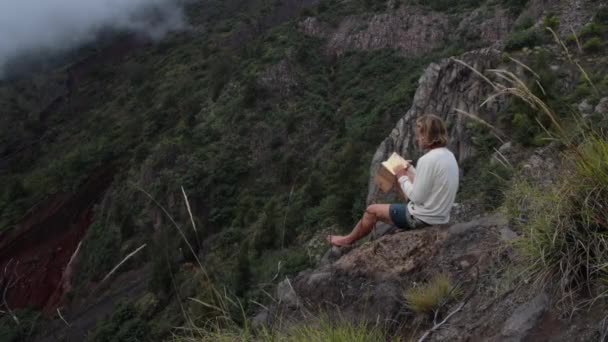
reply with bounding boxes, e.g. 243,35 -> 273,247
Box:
0,0 -> 185,78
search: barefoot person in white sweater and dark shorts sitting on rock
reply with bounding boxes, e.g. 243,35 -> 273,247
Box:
327,115 -> 459,246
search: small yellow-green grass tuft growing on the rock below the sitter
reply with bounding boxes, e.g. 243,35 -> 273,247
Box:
403,274 -> 460,314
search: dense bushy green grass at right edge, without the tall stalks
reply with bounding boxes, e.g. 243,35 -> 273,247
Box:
506,136 -> 608,300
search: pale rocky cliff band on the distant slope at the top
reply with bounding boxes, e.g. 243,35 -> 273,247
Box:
299,6 -> 514,56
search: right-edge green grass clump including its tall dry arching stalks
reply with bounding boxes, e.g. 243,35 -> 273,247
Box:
476,46 -> 608,305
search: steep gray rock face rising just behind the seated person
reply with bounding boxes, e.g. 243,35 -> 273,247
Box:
367,48 -> 505,203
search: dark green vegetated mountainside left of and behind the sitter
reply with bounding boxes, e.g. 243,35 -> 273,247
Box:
0,0 -> 460,340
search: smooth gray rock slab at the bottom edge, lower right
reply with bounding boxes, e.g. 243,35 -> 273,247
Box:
501,293 -> 549,342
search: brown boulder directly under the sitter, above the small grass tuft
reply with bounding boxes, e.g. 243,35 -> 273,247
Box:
275,216 -> 507,322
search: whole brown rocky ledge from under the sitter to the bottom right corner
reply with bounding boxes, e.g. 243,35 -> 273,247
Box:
270,214 -> 603,341
